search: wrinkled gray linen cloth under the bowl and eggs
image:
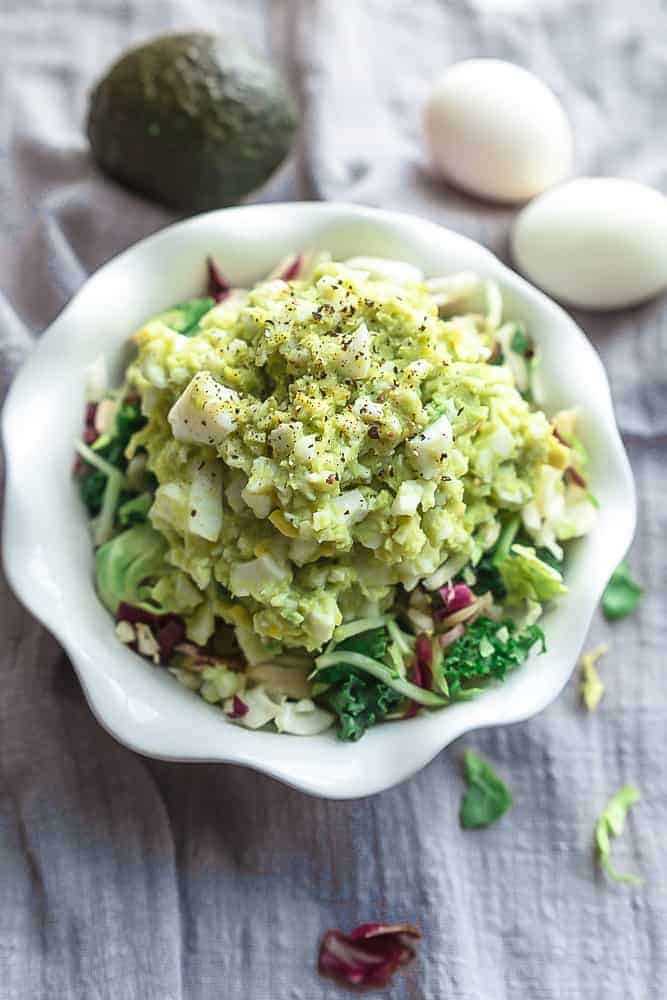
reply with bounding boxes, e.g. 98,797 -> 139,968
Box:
0,0 -> 667,1000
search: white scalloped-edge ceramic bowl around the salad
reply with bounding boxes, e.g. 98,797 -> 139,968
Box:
3,203 -> 636,799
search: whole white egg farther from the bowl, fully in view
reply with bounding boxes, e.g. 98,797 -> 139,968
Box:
424,59 -> 573,202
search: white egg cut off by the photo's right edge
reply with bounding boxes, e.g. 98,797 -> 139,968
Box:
512,177 -> 667,309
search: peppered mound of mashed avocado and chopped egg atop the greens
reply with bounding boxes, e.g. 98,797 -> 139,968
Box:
127,261 -> 581,650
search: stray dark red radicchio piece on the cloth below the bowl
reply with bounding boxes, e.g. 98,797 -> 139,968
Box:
317,923 -> 421,987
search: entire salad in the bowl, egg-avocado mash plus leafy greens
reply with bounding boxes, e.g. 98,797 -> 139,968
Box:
75,254 -> 595,740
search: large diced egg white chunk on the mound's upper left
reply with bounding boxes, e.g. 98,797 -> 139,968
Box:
169,372 -> 239,444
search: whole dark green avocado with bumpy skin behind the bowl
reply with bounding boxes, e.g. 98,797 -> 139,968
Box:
87,33 -> 298,212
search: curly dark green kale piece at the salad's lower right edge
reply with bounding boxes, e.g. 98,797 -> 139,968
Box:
442,616 -> 546,699
